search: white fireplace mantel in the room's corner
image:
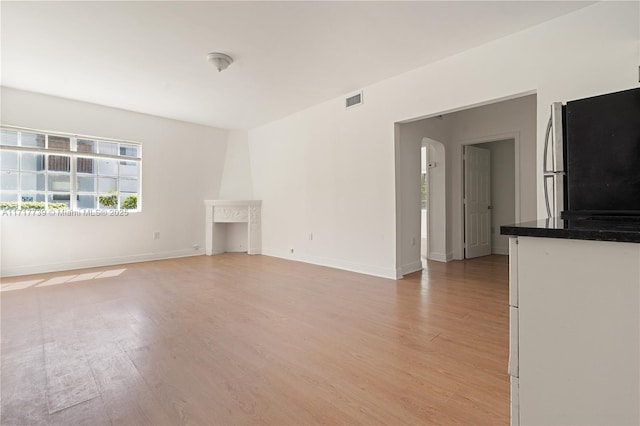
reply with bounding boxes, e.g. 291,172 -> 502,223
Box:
204,200 -> 262,256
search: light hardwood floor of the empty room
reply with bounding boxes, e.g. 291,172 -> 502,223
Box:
0,254 -> 509,425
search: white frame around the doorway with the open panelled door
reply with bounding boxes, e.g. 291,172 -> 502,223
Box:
456,132 -> 521,259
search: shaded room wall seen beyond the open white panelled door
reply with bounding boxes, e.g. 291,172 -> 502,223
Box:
474,140 -> 516,255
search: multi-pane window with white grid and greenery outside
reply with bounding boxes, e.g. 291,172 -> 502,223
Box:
0,126 -> 142,210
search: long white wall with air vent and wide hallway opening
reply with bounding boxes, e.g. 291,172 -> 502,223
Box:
249,2 -> 640,277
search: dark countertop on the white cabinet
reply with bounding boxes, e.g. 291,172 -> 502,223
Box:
500,218 -> 640,243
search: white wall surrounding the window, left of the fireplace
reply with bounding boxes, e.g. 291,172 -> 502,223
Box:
0,88 -> 227,276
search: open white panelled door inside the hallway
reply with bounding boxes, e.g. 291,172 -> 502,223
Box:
464,146 -> 491,259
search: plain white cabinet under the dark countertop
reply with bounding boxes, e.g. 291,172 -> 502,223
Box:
509,237 -> 640,425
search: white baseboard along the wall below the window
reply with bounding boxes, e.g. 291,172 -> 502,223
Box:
0,248 -> 204,277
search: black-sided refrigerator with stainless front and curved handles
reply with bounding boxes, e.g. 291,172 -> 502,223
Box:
543,88 -> 640,219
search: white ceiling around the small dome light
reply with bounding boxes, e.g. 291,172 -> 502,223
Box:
0,1 -> 593,128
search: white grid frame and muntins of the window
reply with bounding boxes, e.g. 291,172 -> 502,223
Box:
0,124 -> 142,212
